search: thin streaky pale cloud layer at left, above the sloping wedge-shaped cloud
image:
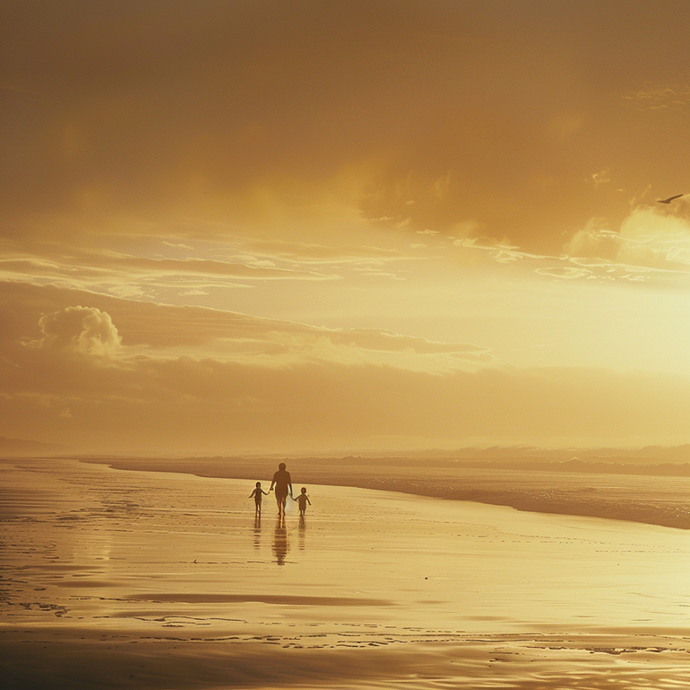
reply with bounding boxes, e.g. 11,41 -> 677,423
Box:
0,226 -> 422,299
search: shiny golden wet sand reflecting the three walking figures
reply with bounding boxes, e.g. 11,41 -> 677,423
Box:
0,460 -> 690,690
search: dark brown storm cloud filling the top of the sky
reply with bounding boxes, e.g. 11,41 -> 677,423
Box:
0,0 -> 690,249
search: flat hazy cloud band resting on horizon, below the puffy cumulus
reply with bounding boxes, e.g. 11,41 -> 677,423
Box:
0,334 -> 690,453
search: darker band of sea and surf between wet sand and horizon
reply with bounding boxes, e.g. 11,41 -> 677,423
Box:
77,458 -> 690,530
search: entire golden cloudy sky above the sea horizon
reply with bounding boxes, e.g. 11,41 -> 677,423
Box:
0,0 -> 690,454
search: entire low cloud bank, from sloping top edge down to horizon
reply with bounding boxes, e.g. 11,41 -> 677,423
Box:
0,284 -> 690,452
